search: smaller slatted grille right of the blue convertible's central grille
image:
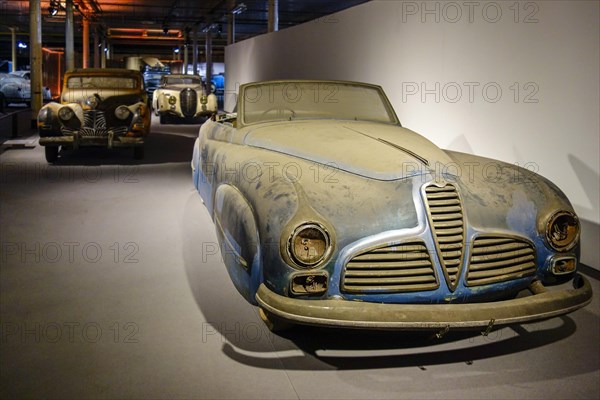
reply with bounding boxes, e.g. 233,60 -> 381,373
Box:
467,236 -> 536,286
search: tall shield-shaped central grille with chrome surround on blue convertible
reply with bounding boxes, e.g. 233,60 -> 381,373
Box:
425,184 -> 465,290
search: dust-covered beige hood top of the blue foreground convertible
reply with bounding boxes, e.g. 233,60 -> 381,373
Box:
244,121 -> 453,181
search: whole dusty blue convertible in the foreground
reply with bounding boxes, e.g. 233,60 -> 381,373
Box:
191,81 -> 592,331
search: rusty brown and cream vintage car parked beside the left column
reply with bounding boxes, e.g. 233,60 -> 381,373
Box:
37,68 -> 151,163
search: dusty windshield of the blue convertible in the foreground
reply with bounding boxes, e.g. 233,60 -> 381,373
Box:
240,81 -> 397,124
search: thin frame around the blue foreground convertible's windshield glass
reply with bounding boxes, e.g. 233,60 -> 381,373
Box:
237,80 -> 401,127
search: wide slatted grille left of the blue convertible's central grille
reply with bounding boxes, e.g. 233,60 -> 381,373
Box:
342,240 -> 438,293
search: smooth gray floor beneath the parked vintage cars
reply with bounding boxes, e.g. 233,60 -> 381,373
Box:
0,114 -> 600,399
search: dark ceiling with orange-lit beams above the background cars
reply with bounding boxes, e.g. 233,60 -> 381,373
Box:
0,0 -> 367,65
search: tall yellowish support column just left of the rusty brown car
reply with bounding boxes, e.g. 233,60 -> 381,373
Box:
29,0 -> 42,128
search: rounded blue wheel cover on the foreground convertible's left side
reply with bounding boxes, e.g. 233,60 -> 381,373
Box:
214,184 -> 262,304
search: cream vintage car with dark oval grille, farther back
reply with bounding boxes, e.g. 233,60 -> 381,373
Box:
152,74 -> 218,124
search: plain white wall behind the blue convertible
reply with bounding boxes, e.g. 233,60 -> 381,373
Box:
225,0 -> 600,269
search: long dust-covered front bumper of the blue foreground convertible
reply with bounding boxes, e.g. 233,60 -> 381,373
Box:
256,274 -> 592,330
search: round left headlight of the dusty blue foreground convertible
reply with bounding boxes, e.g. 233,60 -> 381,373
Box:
288,223 -> 331,268
